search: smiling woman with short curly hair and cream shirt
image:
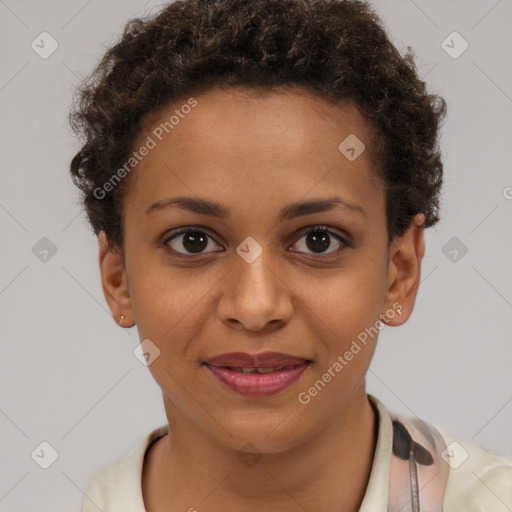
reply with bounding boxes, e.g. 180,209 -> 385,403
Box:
71,0 -> 512,512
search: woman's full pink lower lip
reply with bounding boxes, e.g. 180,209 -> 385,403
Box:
204,361 -> 310,398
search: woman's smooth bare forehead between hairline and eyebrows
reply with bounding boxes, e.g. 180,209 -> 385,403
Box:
124,88 -> 383,221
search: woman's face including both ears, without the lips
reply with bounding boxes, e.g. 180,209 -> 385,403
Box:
100,89 -> 422,453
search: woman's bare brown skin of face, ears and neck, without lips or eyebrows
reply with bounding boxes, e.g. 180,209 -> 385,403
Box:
99,88 -> 424,512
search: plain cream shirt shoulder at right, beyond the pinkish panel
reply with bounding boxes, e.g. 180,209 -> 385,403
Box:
438,428 -> 512,512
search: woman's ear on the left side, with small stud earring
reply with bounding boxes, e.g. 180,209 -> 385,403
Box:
98,231 -> 134,327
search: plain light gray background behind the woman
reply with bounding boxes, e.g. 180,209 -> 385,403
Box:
0,0 -> 512,512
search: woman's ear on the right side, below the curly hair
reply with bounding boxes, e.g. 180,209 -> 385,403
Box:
381,214 -> 425,326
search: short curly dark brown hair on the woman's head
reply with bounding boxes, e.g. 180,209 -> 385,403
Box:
69,0 -> 446,256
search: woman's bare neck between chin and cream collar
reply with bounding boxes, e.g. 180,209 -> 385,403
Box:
143,384 -> 377,512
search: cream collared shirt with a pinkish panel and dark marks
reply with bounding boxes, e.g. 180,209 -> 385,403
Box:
83,395 -> 512,512
